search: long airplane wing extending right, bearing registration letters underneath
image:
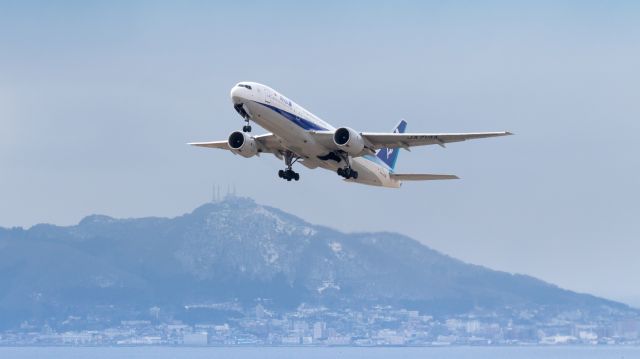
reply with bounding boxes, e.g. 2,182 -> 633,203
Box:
361,131 -> 512,150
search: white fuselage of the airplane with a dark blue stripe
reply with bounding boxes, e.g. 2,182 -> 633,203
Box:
231,82 -> 401,188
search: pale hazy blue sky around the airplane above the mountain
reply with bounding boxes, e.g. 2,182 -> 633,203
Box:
0,1 -> 640,306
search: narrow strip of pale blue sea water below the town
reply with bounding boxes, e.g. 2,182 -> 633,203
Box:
0,346 -> 640,359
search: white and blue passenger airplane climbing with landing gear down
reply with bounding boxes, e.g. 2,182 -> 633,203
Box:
189,81 -> 512,188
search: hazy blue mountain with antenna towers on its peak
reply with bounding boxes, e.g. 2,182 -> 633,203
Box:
0,197 -> 635,328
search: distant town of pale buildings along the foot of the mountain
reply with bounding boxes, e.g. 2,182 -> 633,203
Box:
0,303 -> 640,346
